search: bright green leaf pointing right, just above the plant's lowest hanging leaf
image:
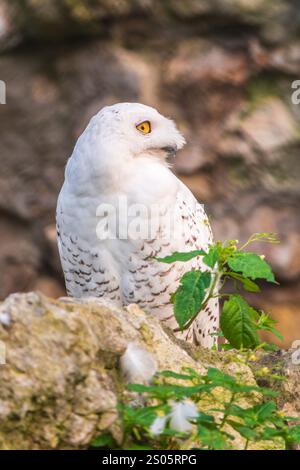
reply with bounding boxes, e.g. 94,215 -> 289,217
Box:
227,251 -> 276,283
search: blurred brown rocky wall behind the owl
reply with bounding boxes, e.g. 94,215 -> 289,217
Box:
0,0 -> 300,345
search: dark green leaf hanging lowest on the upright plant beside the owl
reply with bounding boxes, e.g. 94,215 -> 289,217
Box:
220,295 -> 259,349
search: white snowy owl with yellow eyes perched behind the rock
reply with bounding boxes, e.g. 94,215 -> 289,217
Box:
56,103 -> 219,347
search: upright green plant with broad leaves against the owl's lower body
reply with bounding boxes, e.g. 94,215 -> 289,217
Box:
158,233 -> 283,349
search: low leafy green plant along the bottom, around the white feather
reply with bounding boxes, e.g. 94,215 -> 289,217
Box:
93,368 -> 300,450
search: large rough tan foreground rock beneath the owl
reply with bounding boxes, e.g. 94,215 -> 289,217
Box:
0,293 -> 292,450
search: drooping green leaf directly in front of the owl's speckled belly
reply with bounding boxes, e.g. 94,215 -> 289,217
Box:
172,270 -> 211,328
